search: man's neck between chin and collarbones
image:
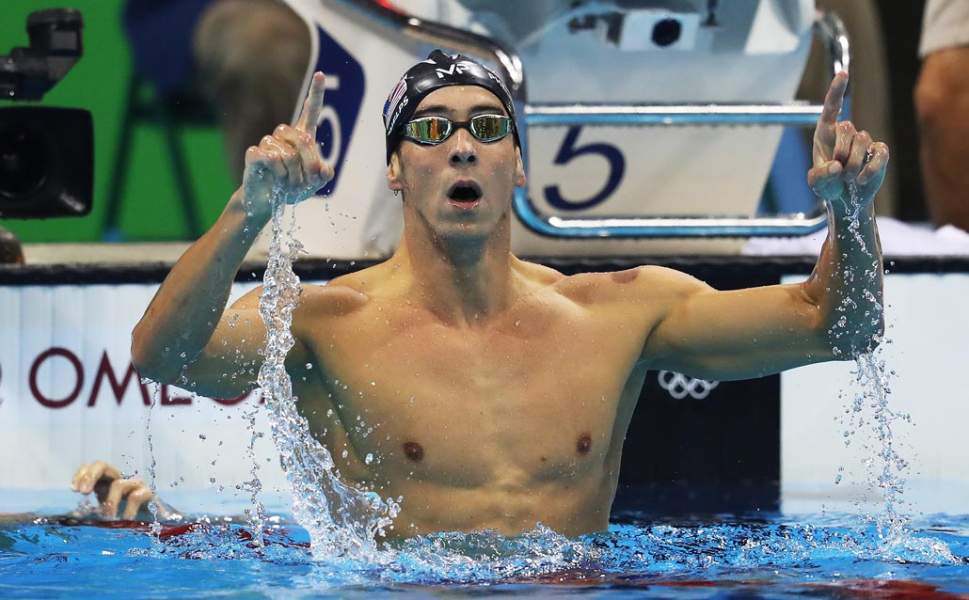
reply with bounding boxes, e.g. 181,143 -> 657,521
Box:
392,219 -> 517,327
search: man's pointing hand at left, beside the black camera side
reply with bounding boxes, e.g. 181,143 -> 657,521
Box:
242,71 -> 333,218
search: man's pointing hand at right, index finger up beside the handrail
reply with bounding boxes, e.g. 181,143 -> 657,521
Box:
808,71 -> 888,214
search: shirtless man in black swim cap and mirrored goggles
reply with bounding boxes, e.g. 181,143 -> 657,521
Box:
74,52 -> 888,536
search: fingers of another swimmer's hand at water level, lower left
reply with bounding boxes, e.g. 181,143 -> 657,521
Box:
71,460 -> 172,521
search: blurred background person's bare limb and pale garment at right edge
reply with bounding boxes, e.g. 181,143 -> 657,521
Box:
915,0 -> 969,231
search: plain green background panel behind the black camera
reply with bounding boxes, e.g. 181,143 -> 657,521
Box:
0,0 -> 234,242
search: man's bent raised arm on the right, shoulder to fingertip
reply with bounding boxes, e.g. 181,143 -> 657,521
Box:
642,73 -> 888,380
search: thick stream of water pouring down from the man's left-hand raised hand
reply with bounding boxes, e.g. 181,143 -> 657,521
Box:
258,189 -> 399,560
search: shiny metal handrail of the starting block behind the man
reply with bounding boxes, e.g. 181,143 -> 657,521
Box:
337,0 -> 851,238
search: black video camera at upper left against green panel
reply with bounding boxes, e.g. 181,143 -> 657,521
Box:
0,9 -> 94,218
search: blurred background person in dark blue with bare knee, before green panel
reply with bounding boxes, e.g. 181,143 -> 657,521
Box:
124,0 -> 310,183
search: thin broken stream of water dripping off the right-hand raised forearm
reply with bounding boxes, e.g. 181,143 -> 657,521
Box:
831,183 -> 911,546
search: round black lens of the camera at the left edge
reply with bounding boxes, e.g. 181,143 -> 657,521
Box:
0,125 -> 49,201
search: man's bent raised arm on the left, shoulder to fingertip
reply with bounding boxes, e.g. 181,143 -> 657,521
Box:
131,73 -> 333,397
